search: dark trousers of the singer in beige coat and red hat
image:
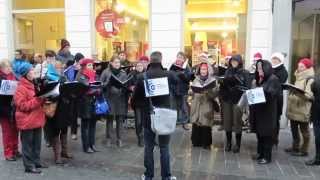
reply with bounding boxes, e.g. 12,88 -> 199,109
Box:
290,120 -> 310,152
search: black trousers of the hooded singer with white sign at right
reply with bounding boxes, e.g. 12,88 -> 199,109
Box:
257,134 -> 273,161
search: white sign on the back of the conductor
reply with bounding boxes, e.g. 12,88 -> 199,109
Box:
144,77 -> 169,97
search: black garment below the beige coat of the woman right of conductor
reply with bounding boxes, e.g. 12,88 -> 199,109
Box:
191,123 -> 212,147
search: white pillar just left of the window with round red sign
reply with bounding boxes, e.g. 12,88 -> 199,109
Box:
65,0 -> 95,57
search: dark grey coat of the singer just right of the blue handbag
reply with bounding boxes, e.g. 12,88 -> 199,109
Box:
100,67 -> 128,116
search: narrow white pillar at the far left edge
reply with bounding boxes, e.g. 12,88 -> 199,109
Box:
0,0 -> 13,59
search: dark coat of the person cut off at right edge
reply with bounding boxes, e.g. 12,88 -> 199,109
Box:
310,77 -> 320,123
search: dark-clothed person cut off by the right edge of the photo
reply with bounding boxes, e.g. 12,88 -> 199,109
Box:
306,77 -> 320,166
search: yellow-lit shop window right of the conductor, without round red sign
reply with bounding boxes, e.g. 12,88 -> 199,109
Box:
184,0 -> 247,65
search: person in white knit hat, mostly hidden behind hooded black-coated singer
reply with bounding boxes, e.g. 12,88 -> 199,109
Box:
271,53 -> 288,146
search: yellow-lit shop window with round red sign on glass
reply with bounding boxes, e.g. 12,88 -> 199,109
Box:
95,0 -> 149,62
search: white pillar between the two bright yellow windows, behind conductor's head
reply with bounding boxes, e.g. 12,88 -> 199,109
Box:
149,0 -> 185,67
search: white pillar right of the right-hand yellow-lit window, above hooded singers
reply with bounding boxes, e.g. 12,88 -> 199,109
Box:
246,0 -> 272,68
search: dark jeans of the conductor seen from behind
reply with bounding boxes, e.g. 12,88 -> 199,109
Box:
144,128 -> 171,180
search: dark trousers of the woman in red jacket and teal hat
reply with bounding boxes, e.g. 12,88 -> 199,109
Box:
21,128 -> 42,169
